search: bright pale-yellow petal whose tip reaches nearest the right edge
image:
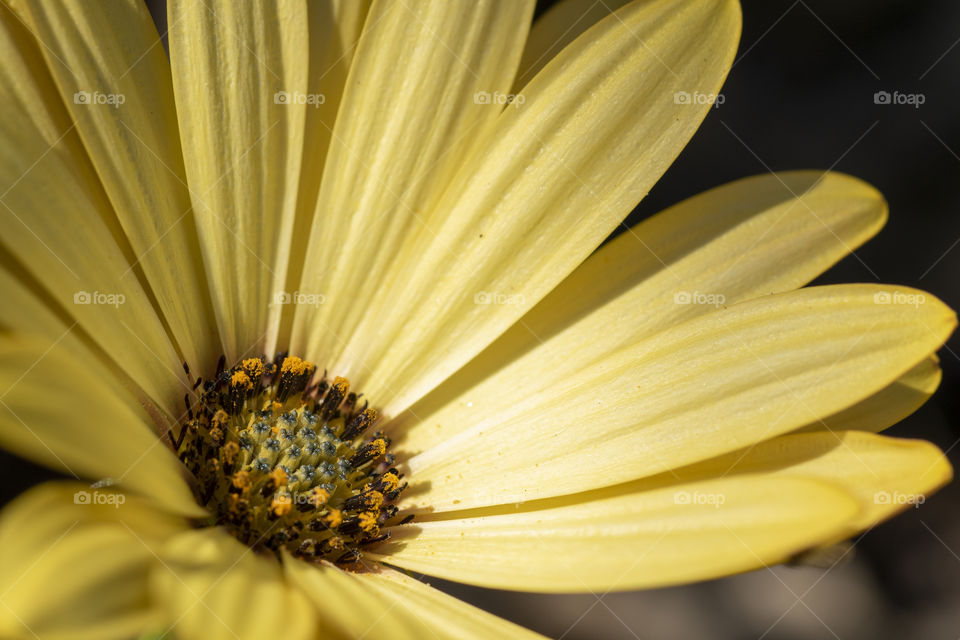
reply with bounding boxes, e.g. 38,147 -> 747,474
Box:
408,285 -> 956,510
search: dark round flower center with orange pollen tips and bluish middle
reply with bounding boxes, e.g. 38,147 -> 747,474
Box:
169,354 -> 407,564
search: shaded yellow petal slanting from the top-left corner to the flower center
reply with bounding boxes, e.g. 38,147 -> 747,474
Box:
23,0 -> 220,364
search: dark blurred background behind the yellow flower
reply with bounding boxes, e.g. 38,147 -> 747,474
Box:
0,0 -> 960,640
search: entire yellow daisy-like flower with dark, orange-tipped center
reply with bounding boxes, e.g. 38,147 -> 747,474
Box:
0,0 -> 956,638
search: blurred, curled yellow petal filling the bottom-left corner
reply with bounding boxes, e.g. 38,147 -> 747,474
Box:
0,482 -> 187,640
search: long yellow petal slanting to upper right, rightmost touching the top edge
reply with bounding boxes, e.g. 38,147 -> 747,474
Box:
332,0 -> 740,415
